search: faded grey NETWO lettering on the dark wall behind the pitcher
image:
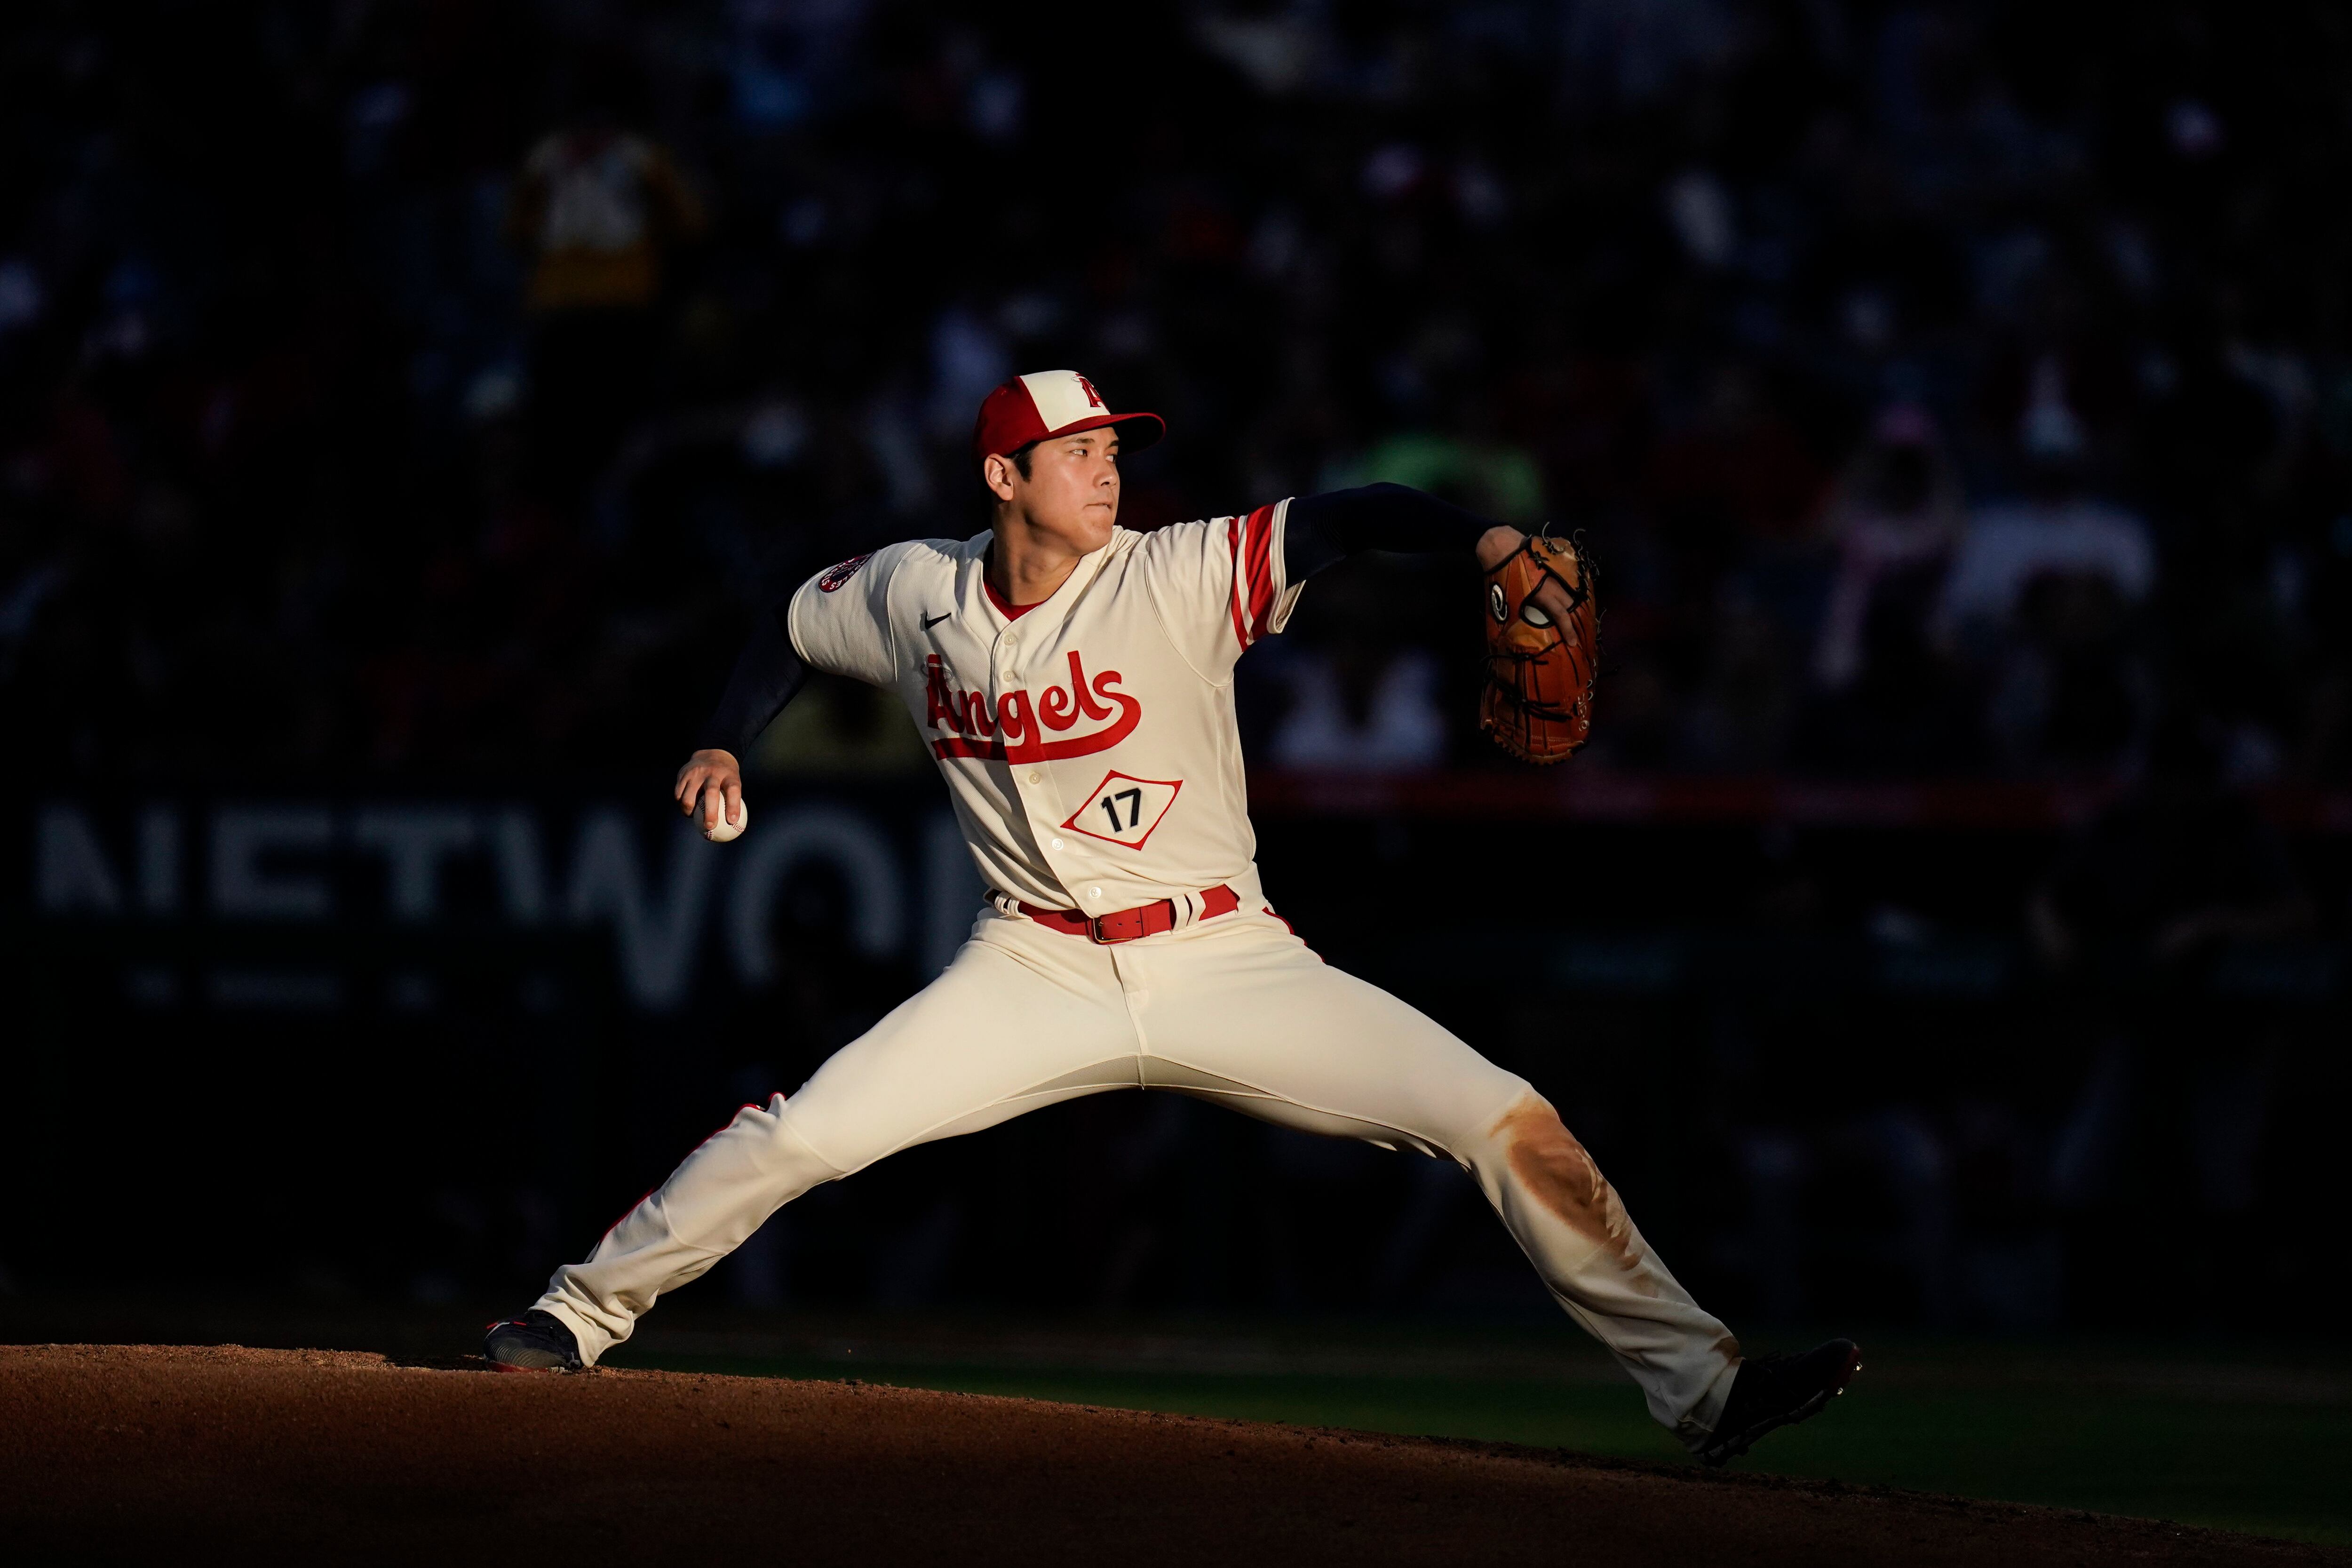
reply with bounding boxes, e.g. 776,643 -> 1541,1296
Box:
19,790 -> 983,1013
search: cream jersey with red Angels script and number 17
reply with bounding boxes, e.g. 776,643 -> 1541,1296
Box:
786,501 -> 1298,915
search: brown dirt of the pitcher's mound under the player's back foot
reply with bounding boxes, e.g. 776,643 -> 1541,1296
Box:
0,1345 -> 2347,1568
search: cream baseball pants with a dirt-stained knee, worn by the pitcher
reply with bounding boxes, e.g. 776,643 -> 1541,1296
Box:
539,879 -> 1738,1441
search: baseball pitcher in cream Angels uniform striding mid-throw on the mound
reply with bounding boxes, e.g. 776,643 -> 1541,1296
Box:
485,372 -> 1860,1465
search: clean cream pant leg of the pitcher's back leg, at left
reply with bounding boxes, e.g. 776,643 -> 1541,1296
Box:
515,912 -> 1138,1363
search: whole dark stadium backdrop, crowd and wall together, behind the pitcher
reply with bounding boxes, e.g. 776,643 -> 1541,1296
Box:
0,0 -> 2352,1542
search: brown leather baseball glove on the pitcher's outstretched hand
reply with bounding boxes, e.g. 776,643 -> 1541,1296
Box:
1477,536 -> 1599,762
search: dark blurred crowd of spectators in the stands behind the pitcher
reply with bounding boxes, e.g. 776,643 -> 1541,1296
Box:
0,0 -> 2352,783
